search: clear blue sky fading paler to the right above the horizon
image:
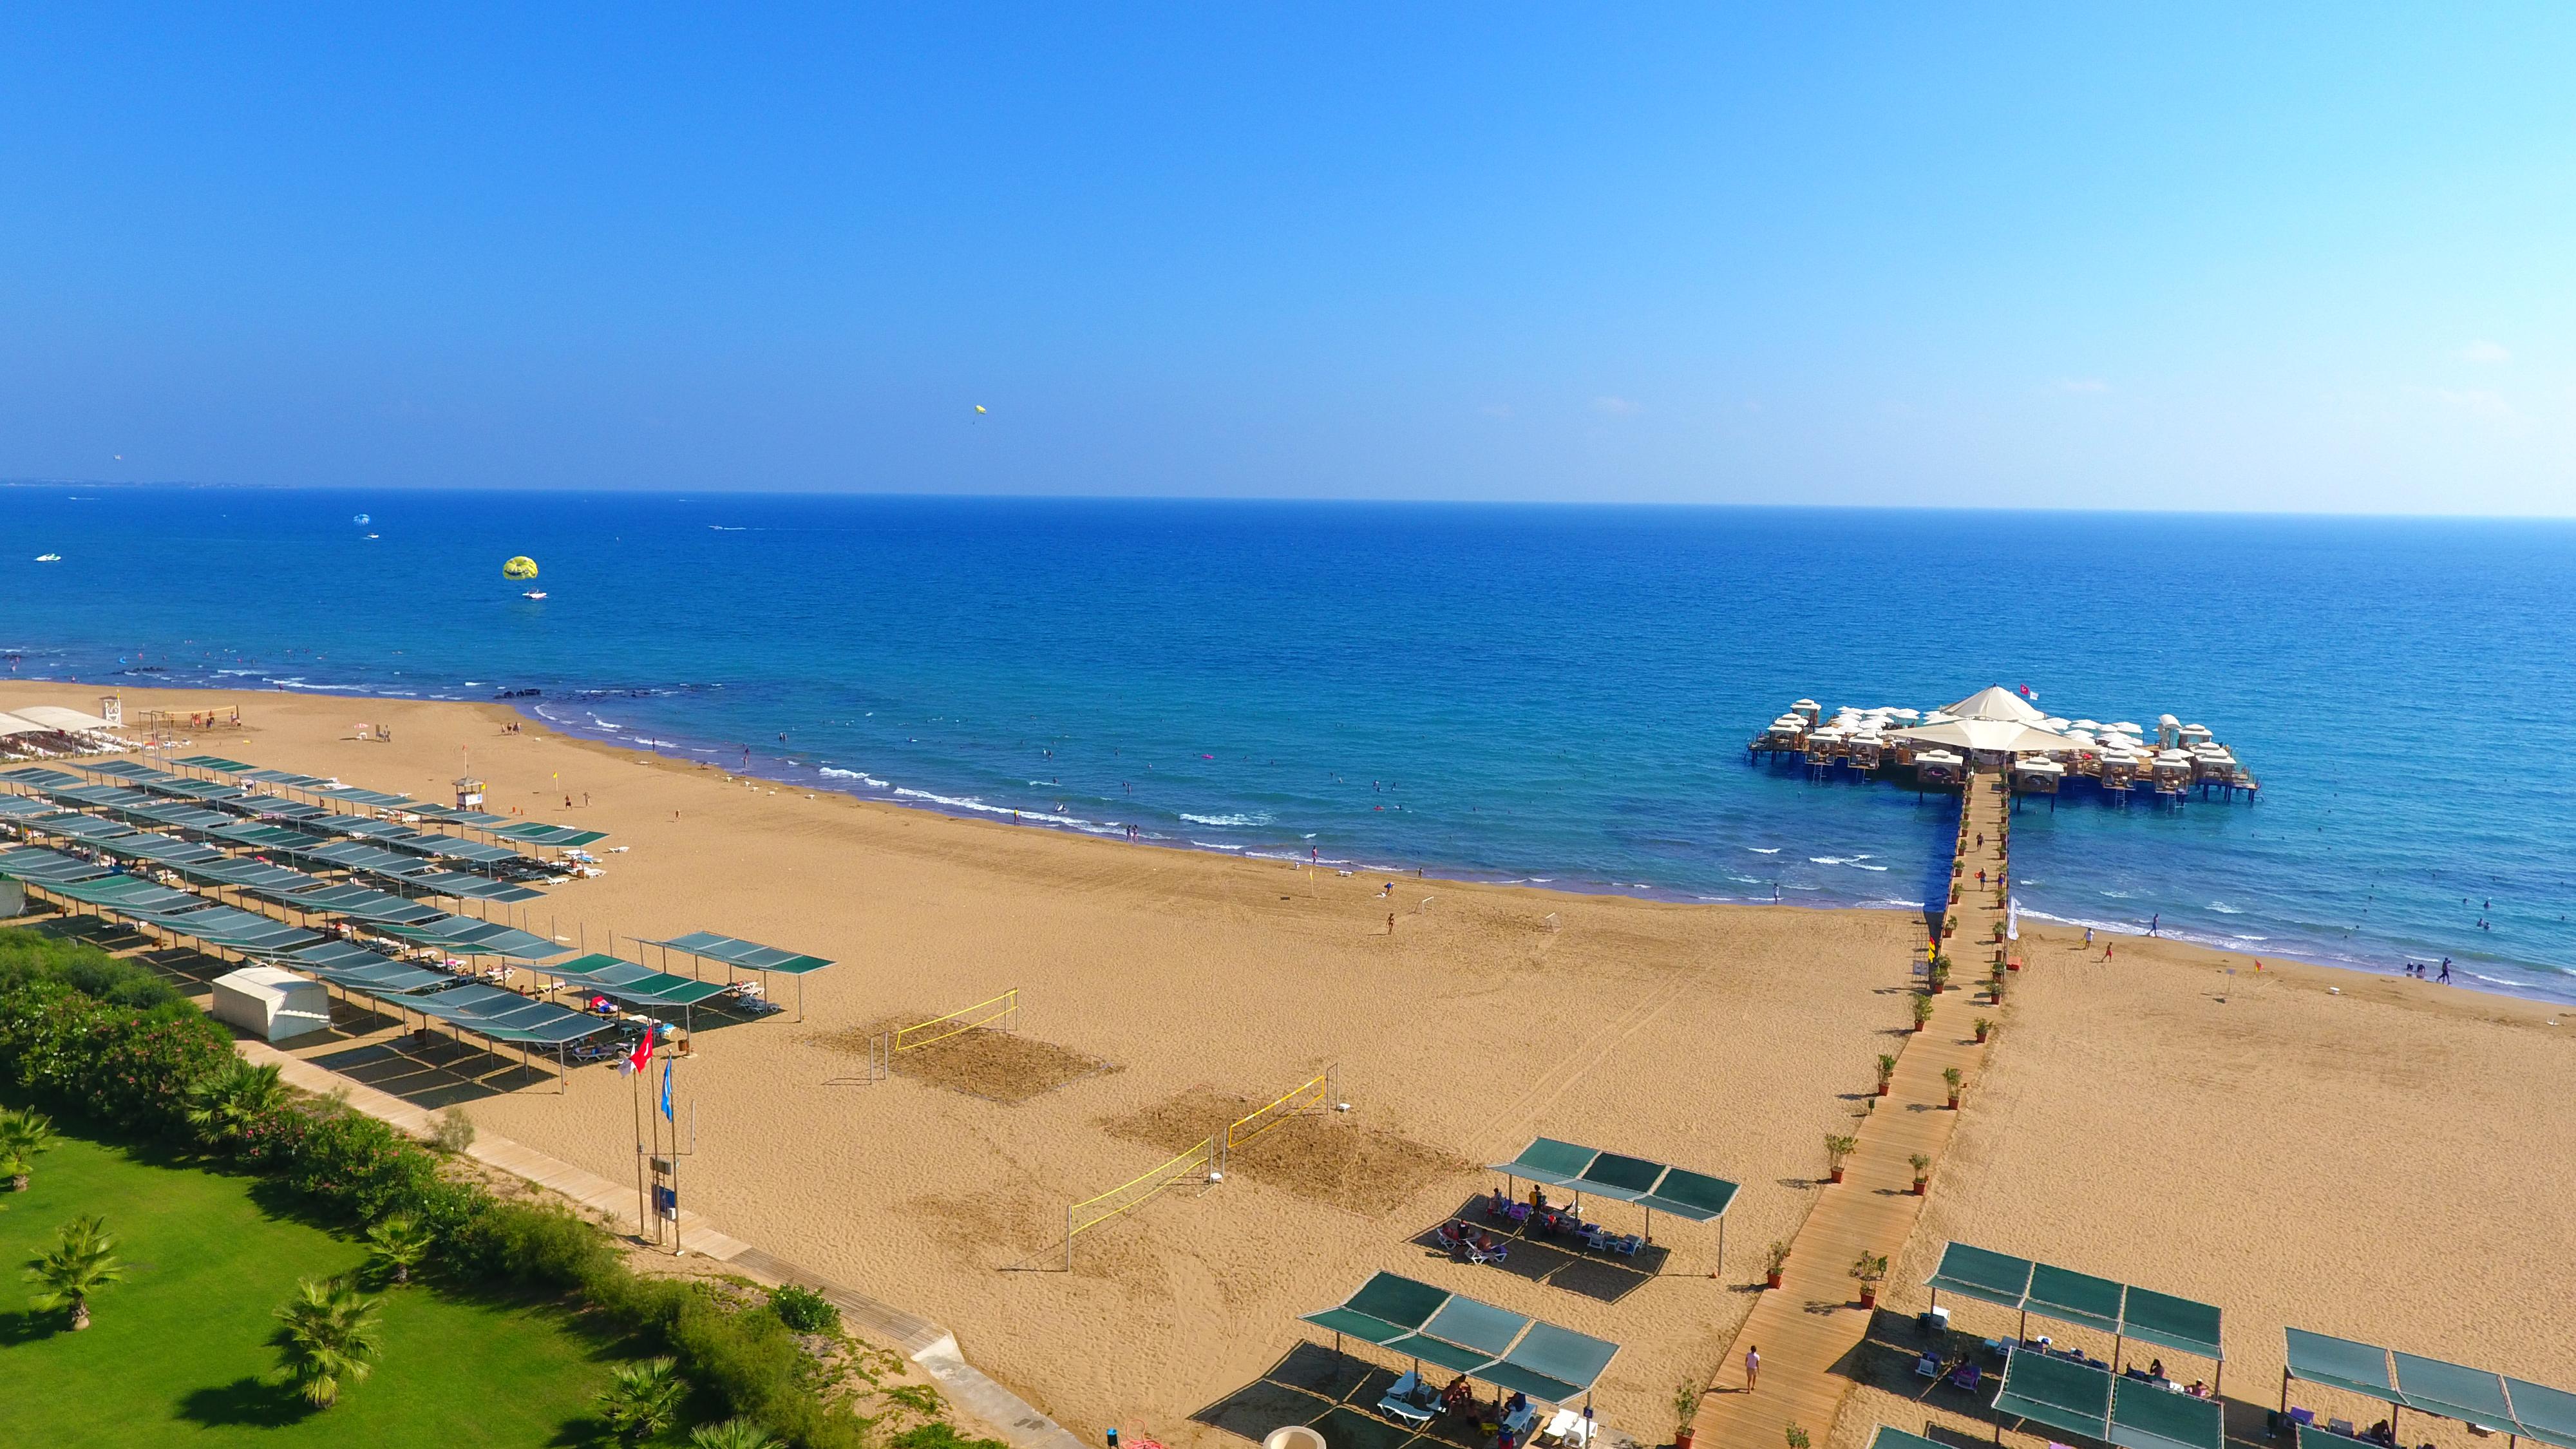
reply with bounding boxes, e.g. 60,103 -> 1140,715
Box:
0,5 -> 2576,513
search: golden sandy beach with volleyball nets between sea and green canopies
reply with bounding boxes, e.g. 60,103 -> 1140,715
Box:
0,683 -> 2576,1446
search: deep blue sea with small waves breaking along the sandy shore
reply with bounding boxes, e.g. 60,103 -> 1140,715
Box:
15,485 -> 2576,1000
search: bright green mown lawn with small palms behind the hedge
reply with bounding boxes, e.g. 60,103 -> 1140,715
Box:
0,1137 -> 654,1449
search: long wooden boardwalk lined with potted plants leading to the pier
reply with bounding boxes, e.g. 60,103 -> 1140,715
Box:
1692,773 -> 2009,1449
